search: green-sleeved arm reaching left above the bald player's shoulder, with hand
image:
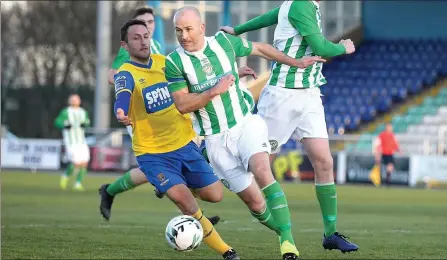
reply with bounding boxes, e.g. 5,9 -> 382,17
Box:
220,7 -> 279,35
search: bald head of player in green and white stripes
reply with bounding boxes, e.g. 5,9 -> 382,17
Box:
174,6 -> 205,52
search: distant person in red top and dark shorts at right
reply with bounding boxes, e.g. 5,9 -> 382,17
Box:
376,124 -> 399,185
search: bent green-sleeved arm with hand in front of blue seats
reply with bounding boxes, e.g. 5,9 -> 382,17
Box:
288,1 -> 355,57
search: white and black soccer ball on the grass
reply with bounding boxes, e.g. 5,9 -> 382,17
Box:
165,215 -> 203,251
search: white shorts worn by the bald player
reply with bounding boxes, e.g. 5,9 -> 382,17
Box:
205,114 -> 270,193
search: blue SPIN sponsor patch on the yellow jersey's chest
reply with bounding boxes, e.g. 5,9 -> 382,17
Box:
142,82 -> 174,114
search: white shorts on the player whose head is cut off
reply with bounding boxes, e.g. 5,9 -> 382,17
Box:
258,86 -> 328,153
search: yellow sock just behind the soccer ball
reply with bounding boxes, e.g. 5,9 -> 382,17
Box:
192,209 -> 231,255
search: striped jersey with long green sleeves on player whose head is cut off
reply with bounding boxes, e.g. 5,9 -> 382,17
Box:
234,0 -> 346,88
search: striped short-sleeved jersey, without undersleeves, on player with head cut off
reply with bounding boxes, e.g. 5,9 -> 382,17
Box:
268,0 -> 326,88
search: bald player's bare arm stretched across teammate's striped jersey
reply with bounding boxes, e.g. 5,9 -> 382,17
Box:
250,42 -> 326,69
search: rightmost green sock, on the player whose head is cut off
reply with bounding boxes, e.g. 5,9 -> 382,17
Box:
315,183 -> 337,236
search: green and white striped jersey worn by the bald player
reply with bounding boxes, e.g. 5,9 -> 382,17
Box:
165,32 -> 254,136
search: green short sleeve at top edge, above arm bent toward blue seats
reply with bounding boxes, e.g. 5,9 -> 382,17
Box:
288,1 -> 321,37
